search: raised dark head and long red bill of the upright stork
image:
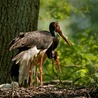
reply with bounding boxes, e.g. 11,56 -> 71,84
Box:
49,22 -> 71,45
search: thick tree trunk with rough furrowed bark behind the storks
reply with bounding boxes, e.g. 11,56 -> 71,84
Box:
0,0 -> 39,84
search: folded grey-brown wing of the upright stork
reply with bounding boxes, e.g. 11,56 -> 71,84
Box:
9,31 -> 53,51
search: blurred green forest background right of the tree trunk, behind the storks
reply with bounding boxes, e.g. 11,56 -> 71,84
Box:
38,0 -> 98,86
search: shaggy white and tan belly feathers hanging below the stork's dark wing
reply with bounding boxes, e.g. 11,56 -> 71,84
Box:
12,46 -> 47,84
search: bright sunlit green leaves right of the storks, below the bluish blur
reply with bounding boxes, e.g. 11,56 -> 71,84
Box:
58,32 -> 98,85
